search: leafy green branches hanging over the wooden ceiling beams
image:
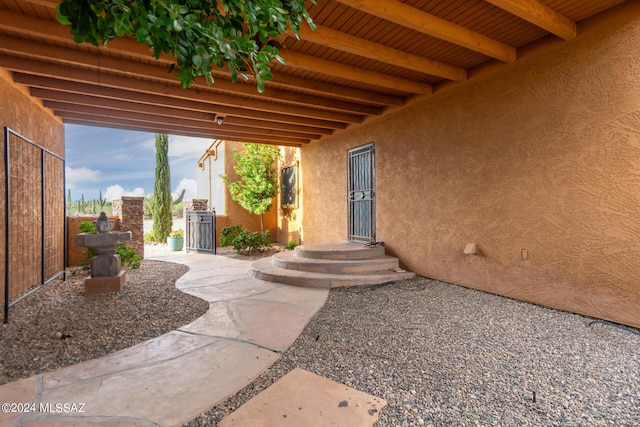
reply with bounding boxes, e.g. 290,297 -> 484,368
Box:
57,0 -> 315,92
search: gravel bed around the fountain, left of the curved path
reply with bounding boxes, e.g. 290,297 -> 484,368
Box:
0,260 -> 209,384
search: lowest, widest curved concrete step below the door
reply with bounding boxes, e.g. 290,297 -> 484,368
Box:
251,258 -> 415,288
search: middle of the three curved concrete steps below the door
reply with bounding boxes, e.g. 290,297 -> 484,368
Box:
272,251 -> 400,274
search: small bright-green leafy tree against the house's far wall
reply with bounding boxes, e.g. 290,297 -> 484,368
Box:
222,143 -> 280,231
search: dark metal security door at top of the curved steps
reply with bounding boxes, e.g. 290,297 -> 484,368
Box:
348,143 -> 376,243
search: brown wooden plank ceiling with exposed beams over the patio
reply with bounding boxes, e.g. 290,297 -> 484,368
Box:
0,0 -> 622,146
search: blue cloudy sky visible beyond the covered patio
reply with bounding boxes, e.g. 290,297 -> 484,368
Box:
65,124 -> 212,201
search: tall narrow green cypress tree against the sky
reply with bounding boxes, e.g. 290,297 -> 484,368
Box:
151,134 -> 173,242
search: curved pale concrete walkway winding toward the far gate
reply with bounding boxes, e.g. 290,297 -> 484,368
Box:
0,246 -> 328,427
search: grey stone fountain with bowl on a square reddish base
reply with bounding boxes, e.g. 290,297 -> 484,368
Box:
74,212 -> 131,294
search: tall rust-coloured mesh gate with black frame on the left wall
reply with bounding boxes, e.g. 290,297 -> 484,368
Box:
0,127 -> 66,323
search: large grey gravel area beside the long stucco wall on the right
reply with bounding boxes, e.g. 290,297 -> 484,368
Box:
186,277 -> 640,427
